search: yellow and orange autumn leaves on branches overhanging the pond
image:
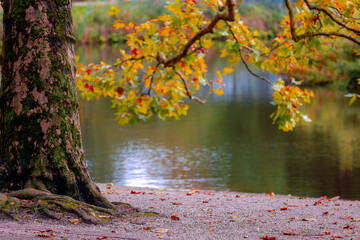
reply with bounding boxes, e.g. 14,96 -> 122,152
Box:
77,0 -> 360,132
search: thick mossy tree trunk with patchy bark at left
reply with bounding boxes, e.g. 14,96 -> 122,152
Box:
0,0 -> 112,207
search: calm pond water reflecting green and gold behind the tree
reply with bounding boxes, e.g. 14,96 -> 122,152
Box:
77,45 -> 360,199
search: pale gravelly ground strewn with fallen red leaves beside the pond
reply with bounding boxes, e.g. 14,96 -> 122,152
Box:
0,184 -> 360,240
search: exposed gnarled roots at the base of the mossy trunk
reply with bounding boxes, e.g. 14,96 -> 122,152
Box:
0,188 -> 146,224
